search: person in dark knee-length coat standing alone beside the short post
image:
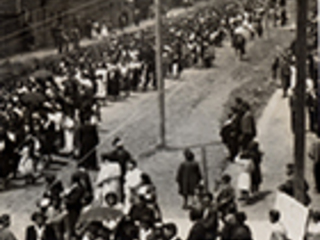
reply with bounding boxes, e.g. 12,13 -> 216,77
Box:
176,149 -> 202,209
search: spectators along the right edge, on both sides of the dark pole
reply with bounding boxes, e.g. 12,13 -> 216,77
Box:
272,0 -> 320,199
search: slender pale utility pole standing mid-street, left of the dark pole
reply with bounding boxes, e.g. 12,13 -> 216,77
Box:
155,0 -> 166,148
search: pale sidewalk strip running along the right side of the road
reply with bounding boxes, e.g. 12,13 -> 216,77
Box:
226,90 -> 320,240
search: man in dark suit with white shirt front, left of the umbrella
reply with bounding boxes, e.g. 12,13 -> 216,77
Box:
25,212 -> 57,240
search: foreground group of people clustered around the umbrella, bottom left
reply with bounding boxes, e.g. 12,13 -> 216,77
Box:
0,135 -> 188,240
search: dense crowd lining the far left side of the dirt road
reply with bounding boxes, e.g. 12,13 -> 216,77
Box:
0,1 -> 245,188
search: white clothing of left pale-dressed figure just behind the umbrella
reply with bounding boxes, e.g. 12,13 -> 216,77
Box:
95,159 -> 121,205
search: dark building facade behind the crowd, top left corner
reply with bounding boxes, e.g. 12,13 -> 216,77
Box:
0,0 -> 134,58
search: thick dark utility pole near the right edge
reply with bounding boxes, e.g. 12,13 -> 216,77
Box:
294,0 -> 308,202
